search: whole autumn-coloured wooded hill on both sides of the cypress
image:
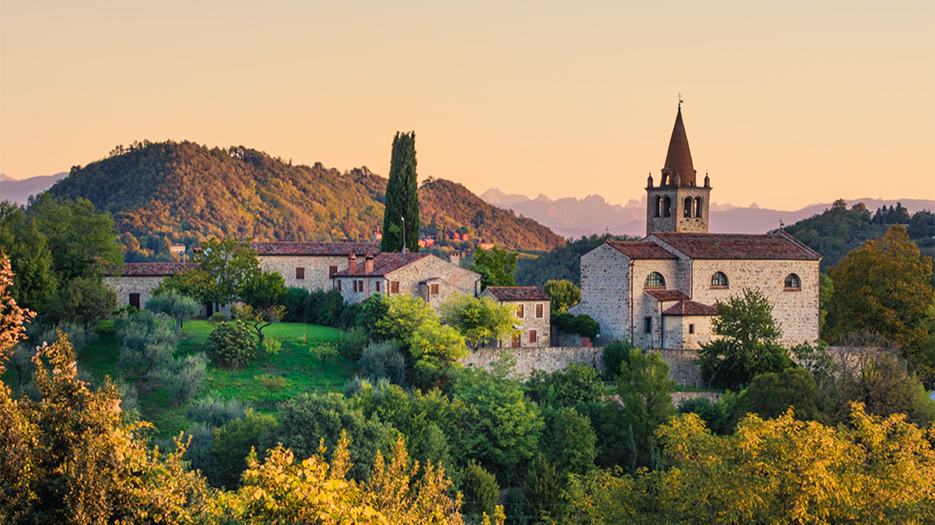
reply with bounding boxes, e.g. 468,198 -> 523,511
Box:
49,141 -> 563,260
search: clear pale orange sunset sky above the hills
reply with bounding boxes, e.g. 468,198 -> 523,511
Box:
0,0 -> 935,210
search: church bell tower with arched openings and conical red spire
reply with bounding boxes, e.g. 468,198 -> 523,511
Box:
646,105 -> 711,235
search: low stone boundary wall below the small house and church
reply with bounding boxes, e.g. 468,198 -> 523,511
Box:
460,346 -> 703,387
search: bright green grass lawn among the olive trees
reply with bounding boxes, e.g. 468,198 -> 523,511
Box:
16,320 -> 359,438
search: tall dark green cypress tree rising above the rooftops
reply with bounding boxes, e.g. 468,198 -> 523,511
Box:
380,131 -> 419,253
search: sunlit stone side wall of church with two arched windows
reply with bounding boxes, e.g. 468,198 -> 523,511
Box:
691,260 -> 819,347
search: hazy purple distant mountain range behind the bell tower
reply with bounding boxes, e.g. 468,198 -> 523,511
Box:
480,188 -> 935,238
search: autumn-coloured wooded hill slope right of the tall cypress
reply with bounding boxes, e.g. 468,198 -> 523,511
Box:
419,179 -> 565,250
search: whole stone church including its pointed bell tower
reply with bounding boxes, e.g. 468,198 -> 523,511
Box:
569,103 -> 821,350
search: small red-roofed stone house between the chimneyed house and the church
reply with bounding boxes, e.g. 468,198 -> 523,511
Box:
480,286 -> 551,348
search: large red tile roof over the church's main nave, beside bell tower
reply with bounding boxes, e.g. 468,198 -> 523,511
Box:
651,232 -> 821,261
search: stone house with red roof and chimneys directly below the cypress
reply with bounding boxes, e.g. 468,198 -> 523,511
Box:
331,253 -> 480,309
